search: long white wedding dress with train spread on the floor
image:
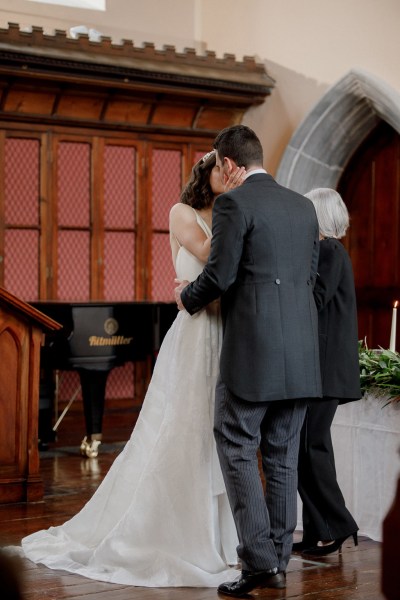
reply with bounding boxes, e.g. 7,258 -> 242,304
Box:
22,213 -> 239,587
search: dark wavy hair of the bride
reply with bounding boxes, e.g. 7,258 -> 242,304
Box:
181,150 -> 216,210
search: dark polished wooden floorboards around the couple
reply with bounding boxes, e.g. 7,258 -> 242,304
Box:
0,404 -> 384,600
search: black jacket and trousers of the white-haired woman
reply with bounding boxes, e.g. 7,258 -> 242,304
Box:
298,238 -> 361,547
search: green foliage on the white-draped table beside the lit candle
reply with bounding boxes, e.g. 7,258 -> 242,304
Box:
358,341 -> 400,402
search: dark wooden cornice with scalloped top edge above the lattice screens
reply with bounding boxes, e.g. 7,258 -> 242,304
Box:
0,24 -> 275,135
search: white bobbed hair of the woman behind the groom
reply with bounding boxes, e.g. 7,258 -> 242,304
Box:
304,188 -> 350,240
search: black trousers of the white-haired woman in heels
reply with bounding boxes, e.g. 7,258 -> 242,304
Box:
298,398 -> 358,543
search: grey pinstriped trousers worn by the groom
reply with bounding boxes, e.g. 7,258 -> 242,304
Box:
214,379 -> 307,571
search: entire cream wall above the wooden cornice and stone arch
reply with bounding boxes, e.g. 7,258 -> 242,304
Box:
0,0 -> 400,174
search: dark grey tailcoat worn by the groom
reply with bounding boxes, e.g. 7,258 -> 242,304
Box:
182,173 -> 322,401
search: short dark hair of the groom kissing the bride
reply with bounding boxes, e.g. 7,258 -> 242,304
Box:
213,125 -> 263,168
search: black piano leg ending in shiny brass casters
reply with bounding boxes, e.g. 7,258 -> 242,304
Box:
78,369 -> 109,458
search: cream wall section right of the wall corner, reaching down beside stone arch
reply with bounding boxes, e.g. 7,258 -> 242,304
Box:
201,0 -> 400,174
